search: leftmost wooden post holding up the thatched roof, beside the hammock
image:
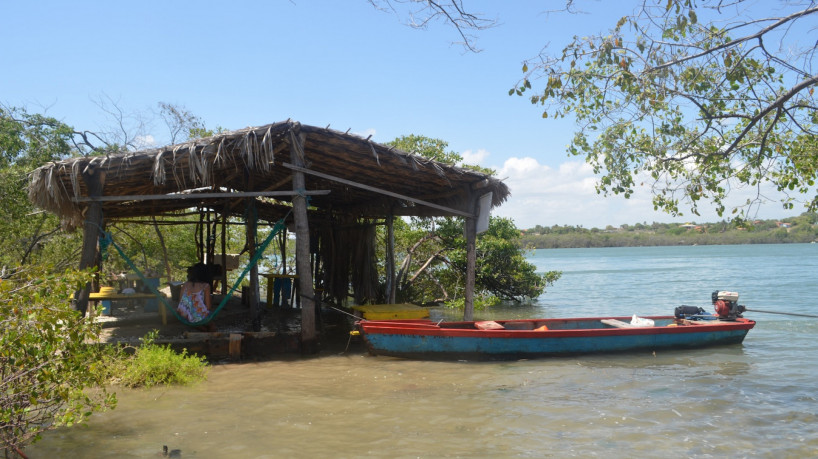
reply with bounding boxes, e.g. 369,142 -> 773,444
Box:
74,166 -> 105,315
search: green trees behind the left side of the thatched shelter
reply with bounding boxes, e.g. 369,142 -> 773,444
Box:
0,103 -> 220,278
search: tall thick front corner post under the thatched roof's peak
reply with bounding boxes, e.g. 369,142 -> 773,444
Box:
290,131 -> 318,354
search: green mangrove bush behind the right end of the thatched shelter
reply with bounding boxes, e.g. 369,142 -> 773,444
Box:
389,135 -> 561,307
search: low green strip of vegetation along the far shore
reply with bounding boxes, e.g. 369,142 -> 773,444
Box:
520,212 -> 818,249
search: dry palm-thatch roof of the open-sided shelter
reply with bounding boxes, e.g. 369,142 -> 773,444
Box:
28,120 -> 509,229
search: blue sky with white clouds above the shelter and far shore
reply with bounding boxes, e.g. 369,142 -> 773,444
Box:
0,0 -> 800,228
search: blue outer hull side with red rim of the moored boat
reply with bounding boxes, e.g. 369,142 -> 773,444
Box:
361,318 -> 755,360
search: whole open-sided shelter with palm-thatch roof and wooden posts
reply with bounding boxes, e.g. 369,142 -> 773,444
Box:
29,120 -> 509,348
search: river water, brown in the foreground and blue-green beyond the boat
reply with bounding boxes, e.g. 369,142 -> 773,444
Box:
28,244 -> 818,458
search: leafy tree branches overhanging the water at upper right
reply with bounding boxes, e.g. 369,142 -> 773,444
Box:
509,0 -> 818,216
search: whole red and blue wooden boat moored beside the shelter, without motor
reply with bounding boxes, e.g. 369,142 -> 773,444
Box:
358,316 -> 755,360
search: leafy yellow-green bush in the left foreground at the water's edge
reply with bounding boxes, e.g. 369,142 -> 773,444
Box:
0,268 -> 116,455
